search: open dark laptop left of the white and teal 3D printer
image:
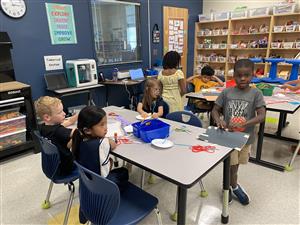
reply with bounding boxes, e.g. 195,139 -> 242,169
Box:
44,72 -> 69,91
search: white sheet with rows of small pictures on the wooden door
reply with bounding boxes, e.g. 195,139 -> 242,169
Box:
168,19 -> 184,55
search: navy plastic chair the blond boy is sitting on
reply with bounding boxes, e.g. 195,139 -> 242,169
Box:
34,131 -> 79,225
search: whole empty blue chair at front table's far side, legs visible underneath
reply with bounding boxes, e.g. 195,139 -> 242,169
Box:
166,111 -> 208,221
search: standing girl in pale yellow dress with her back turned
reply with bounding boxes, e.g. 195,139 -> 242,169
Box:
157,51 -> 186,112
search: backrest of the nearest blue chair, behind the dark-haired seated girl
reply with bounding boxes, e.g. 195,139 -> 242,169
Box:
75,162 -> 120,225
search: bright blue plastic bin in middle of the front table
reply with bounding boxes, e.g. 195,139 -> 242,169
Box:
132,119 -> 170,143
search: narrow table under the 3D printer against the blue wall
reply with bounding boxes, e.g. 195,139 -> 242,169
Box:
47,84 -> 104,105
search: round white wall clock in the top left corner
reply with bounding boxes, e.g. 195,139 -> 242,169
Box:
0,0 -> 26,19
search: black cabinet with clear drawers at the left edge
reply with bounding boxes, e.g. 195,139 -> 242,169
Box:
0,81 -> 39,160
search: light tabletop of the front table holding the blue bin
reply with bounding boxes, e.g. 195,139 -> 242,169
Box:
104,106 -> 232,188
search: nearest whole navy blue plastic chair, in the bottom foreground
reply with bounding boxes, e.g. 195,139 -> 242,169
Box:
75,162 -> 161,225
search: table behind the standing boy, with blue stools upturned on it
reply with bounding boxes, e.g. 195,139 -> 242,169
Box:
186,92 -> 300,171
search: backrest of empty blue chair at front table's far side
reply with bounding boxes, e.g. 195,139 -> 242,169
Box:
166,111 -> 202,127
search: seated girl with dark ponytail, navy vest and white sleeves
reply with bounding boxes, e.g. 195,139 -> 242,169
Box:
72,106 -> 128,223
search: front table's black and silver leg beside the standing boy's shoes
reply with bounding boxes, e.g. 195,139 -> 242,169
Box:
221,155 -> 230,224
